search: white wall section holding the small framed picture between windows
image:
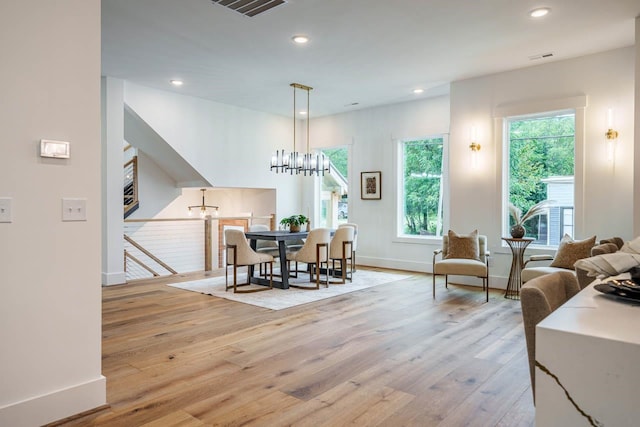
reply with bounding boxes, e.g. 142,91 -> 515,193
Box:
310,97 -> 449,271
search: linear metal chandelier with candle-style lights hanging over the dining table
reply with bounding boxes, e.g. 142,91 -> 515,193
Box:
271,83 -> 329,176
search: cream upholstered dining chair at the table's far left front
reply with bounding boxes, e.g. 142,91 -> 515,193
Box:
224,229 -> 273,293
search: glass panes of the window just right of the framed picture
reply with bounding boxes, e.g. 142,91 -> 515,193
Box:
398,136 -> 445,237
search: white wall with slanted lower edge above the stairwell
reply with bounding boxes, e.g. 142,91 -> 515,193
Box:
125,82 -> 303,218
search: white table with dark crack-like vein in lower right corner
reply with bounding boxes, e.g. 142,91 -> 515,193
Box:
535,283 -> 640,427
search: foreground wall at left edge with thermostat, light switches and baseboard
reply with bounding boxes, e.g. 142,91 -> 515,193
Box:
0,0 -> 106,426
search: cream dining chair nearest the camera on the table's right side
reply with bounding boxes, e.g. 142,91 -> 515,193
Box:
287,228 -> 331,289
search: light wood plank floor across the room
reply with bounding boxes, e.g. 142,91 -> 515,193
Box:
50,273 -> 534,427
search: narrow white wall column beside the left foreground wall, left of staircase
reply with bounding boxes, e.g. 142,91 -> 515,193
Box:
101,77 -> 126,285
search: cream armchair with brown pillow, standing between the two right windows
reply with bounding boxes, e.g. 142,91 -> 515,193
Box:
432,230 -> 490,302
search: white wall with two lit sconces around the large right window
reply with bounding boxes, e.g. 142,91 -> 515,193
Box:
451,48 -> 634,284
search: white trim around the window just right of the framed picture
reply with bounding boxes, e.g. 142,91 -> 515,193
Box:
392,133 -> 449,245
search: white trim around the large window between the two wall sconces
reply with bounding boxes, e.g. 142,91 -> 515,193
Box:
494,95 -> 587,249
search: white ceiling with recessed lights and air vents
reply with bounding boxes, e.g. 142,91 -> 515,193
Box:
102,0 -> 640,118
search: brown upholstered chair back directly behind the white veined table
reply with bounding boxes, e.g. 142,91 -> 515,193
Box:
520,271 -> 580,404
